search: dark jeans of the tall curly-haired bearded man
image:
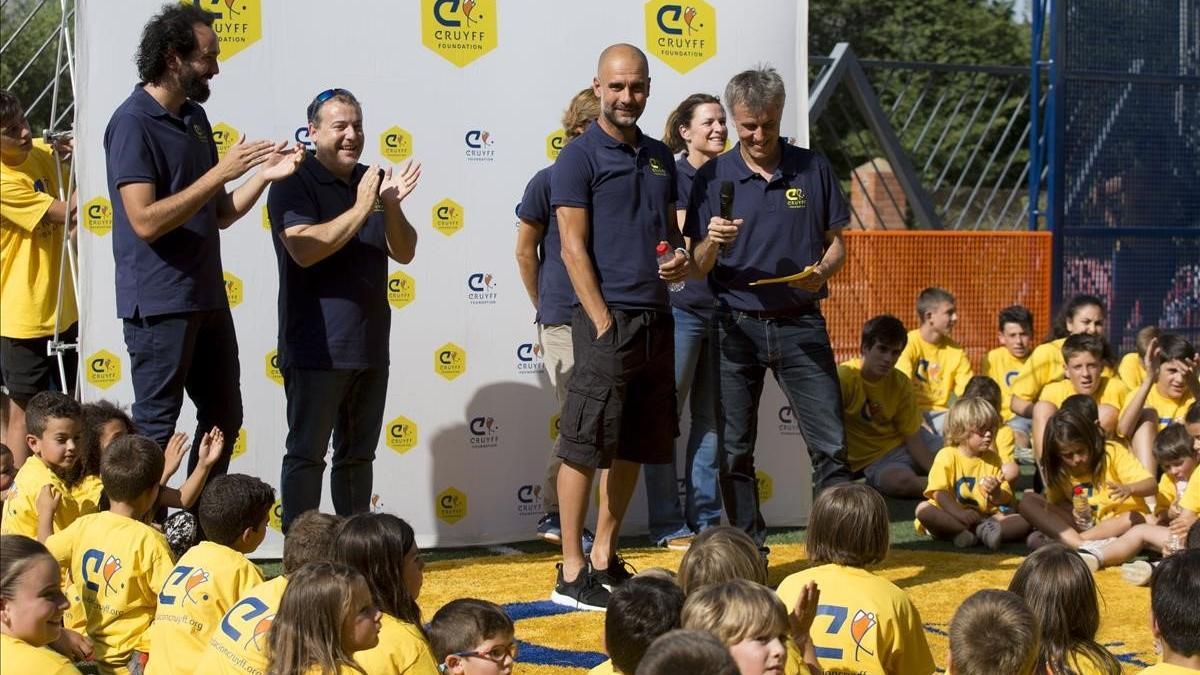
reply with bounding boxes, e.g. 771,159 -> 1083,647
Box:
124,309 -> 241,479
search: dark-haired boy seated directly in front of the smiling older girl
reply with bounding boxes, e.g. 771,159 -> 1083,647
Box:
1033,333 -> 1129,458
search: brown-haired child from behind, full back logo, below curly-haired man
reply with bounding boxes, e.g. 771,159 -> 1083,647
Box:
43,436 -> 174,675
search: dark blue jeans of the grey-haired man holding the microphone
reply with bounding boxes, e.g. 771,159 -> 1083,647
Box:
713,307 -> 851,546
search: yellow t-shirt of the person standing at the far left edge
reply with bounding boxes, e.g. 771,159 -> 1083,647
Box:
0,141 -> 79,338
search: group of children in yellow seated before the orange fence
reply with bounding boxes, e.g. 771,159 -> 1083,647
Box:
838,283 -> 1200,571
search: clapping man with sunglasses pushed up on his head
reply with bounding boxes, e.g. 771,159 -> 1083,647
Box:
266,89 -> 421,531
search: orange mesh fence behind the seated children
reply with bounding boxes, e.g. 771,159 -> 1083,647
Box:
822,231 -> 1052,371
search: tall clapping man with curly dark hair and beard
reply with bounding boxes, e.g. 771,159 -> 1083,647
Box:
104,2 -> 304,474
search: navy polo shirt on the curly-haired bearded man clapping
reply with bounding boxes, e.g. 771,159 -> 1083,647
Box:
104,84 -> 229,318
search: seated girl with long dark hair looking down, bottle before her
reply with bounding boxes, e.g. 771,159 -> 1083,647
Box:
1019,396 -> 1156,568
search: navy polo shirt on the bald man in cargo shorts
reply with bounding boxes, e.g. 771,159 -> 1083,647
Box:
550,124 -> 678,311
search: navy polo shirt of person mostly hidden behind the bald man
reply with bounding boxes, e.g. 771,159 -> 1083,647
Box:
517,167 -> 576,325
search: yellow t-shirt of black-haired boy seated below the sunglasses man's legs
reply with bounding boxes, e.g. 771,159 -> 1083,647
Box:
146,542 -> 263,675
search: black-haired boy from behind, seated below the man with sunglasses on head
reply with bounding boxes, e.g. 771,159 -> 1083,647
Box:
146,473 -> 275,675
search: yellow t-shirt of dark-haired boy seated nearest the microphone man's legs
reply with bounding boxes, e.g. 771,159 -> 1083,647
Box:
838,359 -> 922,471
